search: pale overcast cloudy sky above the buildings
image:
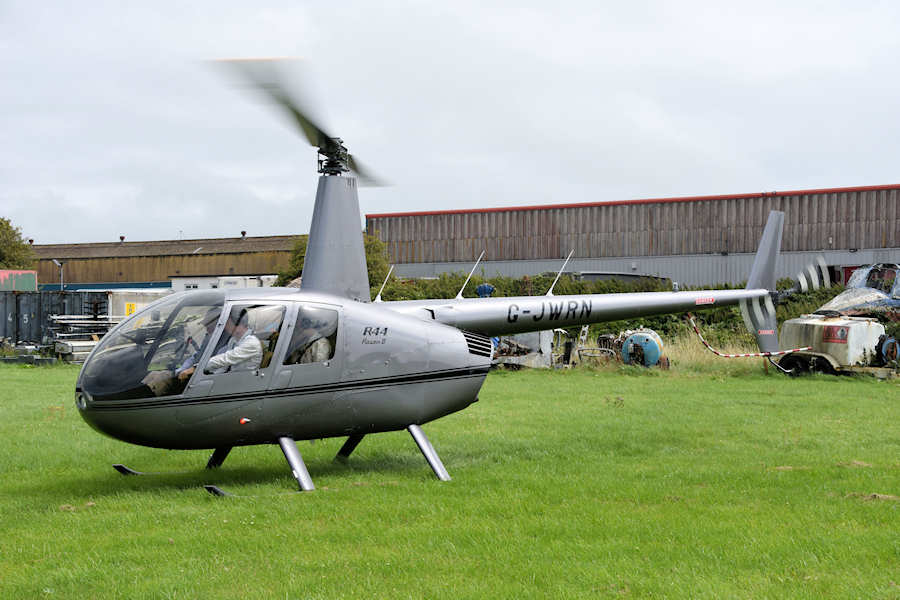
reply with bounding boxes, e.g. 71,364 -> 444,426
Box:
0,0 -> 900,244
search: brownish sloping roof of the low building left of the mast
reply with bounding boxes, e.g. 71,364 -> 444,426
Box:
32,235 -> 299,260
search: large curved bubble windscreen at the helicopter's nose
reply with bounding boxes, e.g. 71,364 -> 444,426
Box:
81,292 -> 225,400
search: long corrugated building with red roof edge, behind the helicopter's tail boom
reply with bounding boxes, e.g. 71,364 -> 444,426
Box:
366,185 -> 900,285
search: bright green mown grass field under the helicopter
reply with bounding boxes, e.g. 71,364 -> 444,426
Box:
0,366 -> 900,598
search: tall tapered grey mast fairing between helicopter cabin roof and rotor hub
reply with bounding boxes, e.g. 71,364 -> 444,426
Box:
301,175 -> 371,302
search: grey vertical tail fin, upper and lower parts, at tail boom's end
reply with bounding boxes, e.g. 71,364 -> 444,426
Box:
740,210 -> 784,352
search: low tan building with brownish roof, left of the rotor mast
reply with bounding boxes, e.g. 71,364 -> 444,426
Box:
33,235 -> 297,290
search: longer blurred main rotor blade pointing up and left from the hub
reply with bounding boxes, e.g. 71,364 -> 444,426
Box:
216,58 -> 332,148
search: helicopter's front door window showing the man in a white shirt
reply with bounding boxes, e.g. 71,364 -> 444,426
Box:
203,304 -> 285,375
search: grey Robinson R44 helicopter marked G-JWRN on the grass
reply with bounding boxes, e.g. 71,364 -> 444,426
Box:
75,61 -> 796,495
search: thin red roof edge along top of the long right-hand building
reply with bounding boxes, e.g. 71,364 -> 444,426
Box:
366,184 -> 900,219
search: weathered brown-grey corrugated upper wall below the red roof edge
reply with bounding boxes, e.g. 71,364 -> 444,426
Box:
366,186 -> 900,264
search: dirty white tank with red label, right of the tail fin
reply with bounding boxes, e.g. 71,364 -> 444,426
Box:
781,315 -> 884,367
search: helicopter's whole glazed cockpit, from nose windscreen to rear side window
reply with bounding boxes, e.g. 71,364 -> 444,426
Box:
80,290 -> 338,401
